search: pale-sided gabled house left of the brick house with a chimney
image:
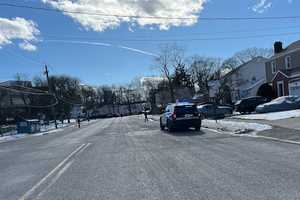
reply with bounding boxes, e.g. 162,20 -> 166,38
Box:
209,57 -> 267,103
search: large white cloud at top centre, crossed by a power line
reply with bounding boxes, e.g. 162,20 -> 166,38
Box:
42,0 -> 207,32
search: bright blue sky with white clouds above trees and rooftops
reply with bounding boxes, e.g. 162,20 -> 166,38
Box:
0,0 -> 300,85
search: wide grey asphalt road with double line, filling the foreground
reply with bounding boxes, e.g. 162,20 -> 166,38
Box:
0,116 -> 300,200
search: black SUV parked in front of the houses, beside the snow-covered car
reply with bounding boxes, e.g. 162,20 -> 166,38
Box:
234,96 -> 268,114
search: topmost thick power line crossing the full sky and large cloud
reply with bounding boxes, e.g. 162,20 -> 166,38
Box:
0,3 -> 300,21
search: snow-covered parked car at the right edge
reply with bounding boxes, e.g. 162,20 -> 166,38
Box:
256,96 -> 300,113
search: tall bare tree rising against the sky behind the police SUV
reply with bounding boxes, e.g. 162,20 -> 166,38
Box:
155,44 -> 184,102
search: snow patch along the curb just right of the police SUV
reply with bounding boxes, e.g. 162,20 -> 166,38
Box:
202,120 -> 272,135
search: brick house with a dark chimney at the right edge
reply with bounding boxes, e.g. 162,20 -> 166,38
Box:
266,40 -> 300,96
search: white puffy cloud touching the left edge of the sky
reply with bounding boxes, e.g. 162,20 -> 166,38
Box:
0,17 -> 40,51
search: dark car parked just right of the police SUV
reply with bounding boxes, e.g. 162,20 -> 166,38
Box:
197,104 -> 233,119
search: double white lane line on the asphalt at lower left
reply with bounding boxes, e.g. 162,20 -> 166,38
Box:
19,144 -> 86,200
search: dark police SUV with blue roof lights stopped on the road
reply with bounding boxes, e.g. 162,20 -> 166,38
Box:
160,103 -> 201,131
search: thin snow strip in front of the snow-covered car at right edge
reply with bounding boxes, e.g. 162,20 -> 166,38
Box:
232,110 -> 300,120
